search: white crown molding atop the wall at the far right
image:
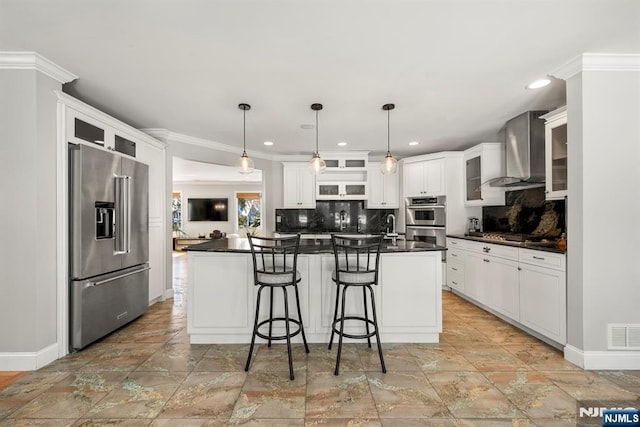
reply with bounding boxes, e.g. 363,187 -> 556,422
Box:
549,53 -> 640,80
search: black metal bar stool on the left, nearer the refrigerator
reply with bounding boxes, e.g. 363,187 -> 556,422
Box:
244,233 -> 309,380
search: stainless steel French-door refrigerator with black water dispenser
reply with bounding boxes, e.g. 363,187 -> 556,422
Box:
69,144 -> 149,351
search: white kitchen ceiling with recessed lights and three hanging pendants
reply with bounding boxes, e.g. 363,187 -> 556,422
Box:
0,0 -> 640,158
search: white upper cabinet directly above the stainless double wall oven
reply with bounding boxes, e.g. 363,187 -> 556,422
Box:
403,158 -> 446,197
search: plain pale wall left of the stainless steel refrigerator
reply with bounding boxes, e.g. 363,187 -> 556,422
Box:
0,70 -> 61,356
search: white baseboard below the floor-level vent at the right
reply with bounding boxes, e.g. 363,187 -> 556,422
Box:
564,344 -> 640,370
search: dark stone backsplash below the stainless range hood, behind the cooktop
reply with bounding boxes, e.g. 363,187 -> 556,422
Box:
482,187 -> 566,237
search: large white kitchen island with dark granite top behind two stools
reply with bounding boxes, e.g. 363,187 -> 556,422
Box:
185,238 -> 446,344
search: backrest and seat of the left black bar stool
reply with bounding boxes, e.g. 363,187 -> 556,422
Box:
247,233 -> 300,284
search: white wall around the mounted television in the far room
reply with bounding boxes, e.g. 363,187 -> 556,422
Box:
173,182 -> 262,237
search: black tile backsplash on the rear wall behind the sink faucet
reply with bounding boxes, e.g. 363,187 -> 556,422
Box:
276,200 -> 394,233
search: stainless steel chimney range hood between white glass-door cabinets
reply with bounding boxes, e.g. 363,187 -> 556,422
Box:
488,111 -> 548,188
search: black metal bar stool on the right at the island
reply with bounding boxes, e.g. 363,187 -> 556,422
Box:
329,234 -> 387,375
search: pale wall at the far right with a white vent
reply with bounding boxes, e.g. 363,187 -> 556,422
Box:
567,61 -> 640,362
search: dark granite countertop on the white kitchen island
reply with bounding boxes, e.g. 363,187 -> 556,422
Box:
183,237 -> 447,254
